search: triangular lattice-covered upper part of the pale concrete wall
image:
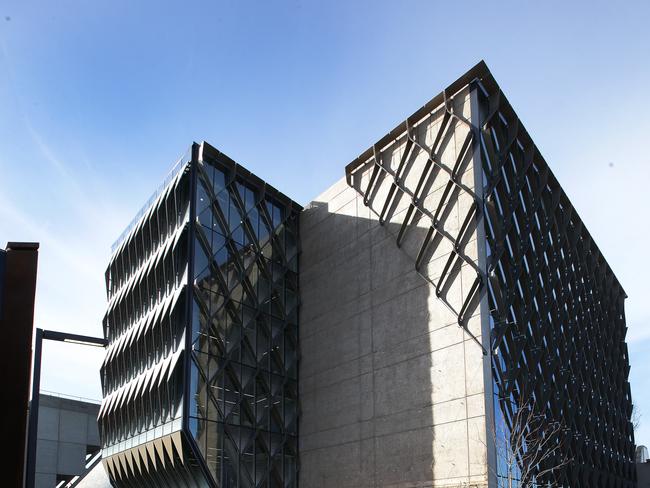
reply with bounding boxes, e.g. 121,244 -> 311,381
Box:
346,74 -> 487,354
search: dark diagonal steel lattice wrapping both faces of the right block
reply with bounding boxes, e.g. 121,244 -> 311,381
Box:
346,62 -> 636,488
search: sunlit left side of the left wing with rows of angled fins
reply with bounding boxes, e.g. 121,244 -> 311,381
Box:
99,158 -> 190,456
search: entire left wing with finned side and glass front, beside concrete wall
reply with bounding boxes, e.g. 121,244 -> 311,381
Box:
99,143 -> 300,487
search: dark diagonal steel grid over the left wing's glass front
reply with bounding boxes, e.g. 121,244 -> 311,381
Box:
187,142 -> 302,487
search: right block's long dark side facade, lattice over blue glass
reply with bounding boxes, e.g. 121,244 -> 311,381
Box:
477,81 -> 636,488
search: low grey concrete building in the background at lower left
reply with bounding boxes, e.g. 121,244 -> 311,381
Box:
36,395 -> 100,488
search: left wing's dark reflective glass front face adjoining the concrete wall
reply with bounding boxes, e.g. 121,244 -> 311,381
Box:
189,146 -> 298,487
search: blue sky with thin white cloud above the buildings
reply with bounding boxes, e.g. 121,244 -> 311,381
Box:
0,0 -> 650,444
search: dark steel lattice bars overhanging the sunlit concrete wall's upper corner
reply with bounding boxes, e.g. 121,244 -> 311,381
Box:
346,81 -> 488,355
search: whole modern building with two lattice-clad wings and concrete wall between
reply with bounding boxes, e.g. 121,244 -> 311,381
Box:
99,62 -> 636,488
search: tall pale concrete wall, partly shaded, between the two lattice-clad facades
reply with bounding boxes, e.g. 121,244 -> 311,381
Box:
300,88 -> 489,488
